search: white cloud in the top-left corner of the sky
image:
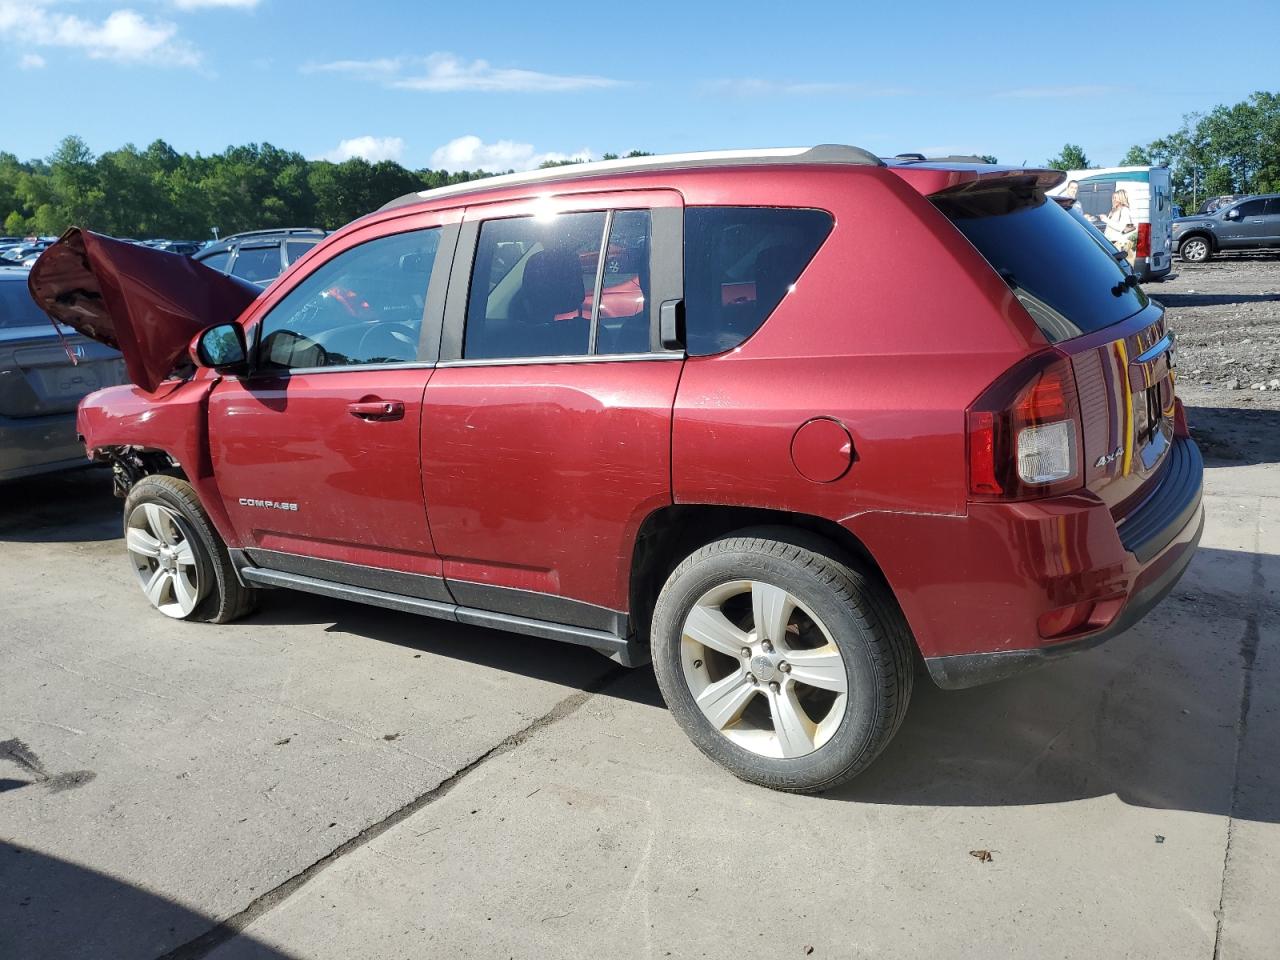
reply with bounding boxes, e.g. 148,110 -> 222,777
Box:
0,0 -> 200,67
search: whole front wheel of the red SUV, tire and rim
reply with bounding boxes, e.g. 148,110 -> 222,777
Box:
124,474 -> 256,623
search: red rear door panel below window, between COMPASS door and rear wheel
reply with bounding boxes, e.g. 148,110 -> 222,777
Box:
422,360 -> 681,611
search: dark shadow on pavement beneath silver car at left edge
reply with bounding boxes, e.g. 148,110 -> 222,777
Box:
0,467 -> 120,543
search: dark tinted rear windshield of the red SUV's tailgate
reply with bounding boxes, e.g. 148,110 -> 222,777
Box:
933,182 -> 1149,343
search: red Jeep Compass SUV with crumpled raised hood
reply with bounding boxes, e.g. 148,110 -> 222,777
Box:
31,146 -> 1203,791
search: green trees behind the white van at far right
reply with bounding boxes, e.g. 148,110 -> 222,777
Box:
1046,91 -> 1280,212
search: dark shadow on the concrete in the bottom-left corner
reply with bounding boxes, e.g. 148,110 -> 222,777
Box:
0,842 -> 291,960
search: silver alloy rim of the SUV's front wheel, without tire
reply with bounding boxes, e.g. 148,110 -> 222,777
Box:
124,503 -> 204,620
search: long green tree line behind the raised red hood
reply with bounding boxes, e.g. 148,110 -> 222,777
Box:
0,136 -> 655,239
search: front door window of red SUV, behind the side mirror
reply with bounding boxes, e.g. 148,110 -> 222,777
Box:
259,227 -> 440,370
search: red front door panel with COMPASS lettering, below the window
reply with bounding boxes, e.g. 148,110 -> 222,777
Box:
209,367 -> 440,576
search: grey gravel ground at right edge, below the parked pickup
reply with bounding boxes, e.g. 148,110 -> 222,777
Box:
1146,252 -> 1280,410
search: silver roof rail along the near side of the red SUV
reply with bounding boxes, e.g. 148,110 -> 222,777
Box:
379,143 -> 884,210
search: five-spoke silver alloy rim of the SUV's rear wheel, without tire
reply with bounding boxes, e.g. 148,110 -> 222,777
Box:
680,580 -> 849,759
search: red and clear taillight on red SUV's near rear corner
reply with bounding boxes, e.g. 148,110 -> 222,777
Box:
966,351 -> 1082,499
